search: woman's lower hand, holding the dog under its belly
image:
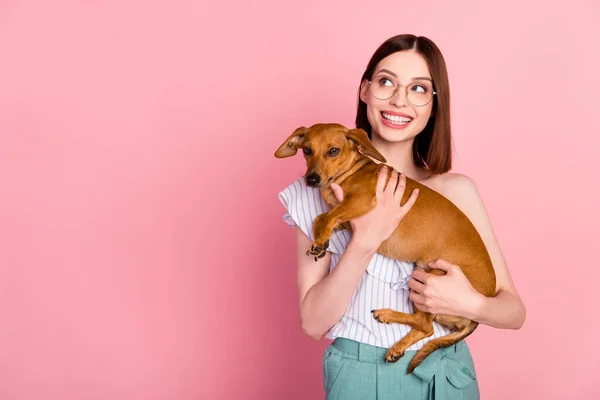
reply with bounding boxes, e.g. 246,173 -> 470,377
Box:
408,260 -> 485,320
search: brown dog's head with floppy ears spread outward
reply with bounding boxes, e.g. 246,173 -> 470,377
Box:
275,124 -> 386,187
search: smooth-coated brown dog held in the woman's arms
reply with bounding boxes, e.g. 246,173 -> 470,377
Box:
275,124 -> 496,373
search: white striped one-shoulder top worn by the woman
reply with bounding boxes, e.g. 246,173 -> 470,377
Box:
279,177 -> 449,350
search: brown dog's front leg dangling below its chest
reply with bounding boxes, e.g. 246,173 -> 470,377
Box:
307,195 -> 374,261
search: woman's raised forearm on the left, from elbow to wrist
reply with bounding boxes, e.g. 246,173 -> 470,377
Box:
300,238 -> 375,340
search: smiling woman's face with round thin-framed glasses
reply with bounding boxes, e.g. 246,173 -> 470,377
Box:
360,50 -> 433,142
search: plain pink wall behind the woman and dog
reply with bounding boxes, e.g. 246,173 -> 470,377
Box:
0,0 -> 600,400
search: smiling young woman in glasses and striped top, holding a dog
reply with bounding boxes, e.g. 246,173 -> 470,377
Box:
279,35 -> 525,400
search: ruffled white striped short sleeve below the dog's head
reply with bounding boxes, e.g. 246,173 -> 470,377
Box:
278,177 -> 349,254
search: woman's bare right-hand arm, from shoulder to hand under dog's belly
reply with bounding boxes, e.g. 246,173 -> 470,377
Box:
409,174 -> 526,329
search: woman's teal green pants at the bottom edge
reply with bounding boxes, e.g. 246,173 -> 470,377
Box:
323,338 -> 479,400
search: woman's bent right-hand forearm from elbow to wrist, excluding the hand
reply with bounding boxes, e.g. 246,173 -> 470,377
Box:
471,289 -> 526,329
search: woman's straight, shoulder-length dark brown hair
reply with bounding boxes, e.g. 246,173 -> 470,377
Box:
356,35 -> 452,174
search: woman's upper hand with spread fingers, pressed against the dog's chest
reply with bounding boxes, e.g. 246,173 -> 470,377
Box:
331,165 -> 419,252
